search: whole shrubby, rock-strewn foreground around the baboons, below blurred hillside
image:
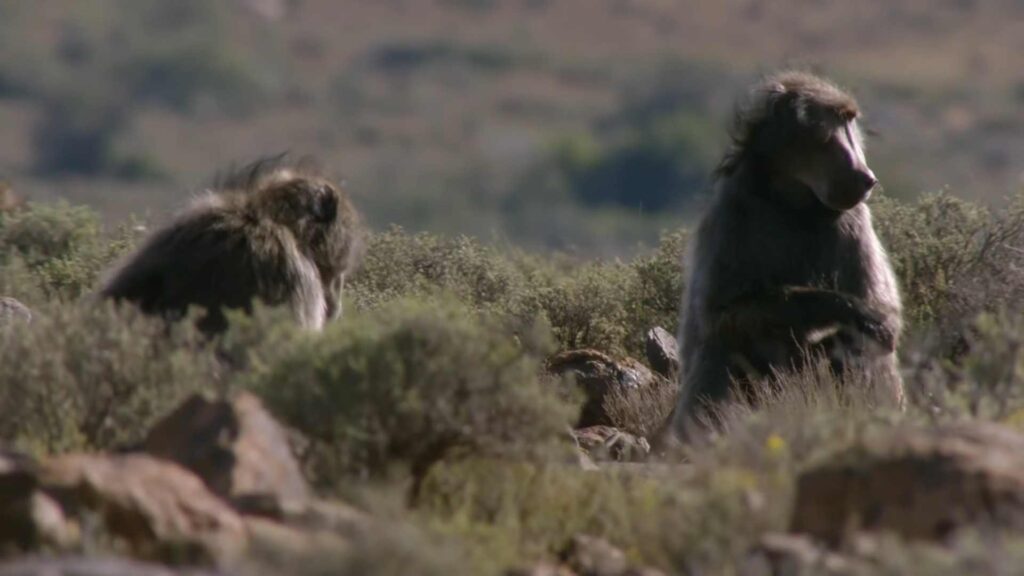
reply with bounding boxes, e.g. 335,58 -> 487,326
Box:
6,196 -> 1024,576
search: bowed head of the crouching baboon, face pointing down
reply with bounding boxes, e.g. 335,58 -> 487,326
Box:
221,158 -> 364,283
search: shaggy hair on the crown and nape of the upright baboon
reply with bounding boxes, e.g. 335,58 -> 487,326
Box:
715,71 -> 860,177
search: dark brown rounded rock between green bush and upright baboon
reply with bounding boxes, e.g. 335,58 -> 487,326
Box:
548,349 -> 676,436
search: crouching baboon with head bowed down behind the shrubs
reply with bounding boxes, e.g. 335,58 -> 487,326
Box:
100,157 -> 362,333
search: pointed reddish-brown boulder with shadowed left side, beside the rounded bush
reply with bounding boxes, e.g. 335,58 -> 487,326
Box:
142,393 -> 309,510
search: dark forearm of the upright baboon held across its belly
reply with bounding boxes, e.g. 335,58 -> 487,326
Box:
713,286 -> 896,352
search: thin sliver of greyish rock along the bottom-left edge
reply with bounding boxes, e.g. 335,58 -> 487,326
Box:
0,556 -> 220,576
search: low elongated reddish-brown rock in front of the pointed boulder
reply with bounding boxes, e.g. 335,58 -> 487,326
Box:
0,454 -> 247,564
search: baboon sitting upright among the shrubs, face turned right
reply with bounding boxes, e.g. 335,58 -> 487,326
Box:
674,72 -> 902,437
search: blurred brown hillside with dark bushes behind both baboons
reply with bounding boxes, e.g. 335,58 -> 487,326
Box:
0,0 -> 1024,255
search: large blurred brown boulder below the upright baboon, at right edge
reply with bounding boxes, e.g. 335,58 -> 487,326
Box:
791,423 -> 1024,546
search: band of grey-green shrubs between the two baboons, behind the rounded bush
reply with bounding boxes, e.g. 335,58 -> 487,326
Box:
348,228 -> 686,356
